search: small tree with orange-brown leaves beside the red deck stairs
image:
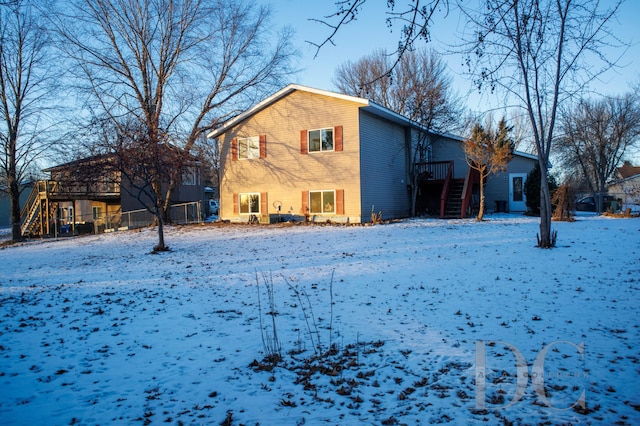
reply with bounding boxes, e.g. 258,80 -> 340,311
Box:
462,118 -> 515,221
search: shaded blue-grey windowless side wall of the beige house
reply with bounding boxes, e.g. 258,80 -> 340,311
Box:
360,111 -> 411,220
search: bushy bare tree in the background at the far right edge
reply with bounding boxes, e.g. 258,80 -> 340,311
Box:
556,93 -> 640,213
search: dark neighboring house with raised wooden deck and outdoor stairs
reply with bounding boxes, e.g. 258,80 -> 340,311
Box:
22,151 -> 204,235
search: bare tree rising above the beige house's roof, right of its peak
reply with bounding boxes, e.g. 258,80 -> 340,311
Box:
334,49 -> 463,215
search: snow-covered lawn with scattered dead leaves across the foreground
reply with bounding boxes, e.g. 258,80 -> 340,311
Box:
0,215 -> 640,425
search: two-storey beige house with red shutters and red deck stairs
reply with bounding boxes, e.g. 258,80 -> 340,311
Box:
208,85 -> 535,223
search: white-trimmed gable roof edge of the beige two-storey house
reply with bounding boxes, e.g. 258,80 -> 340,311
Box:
207,84 -> 426,138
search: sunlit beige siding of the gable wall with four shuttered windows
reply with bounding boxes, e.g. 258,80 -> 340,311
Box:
219,91 -> 360,222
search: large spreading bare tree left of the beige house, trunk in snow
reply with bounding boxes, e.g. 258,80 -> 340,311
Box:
56,0 -> 293,250
